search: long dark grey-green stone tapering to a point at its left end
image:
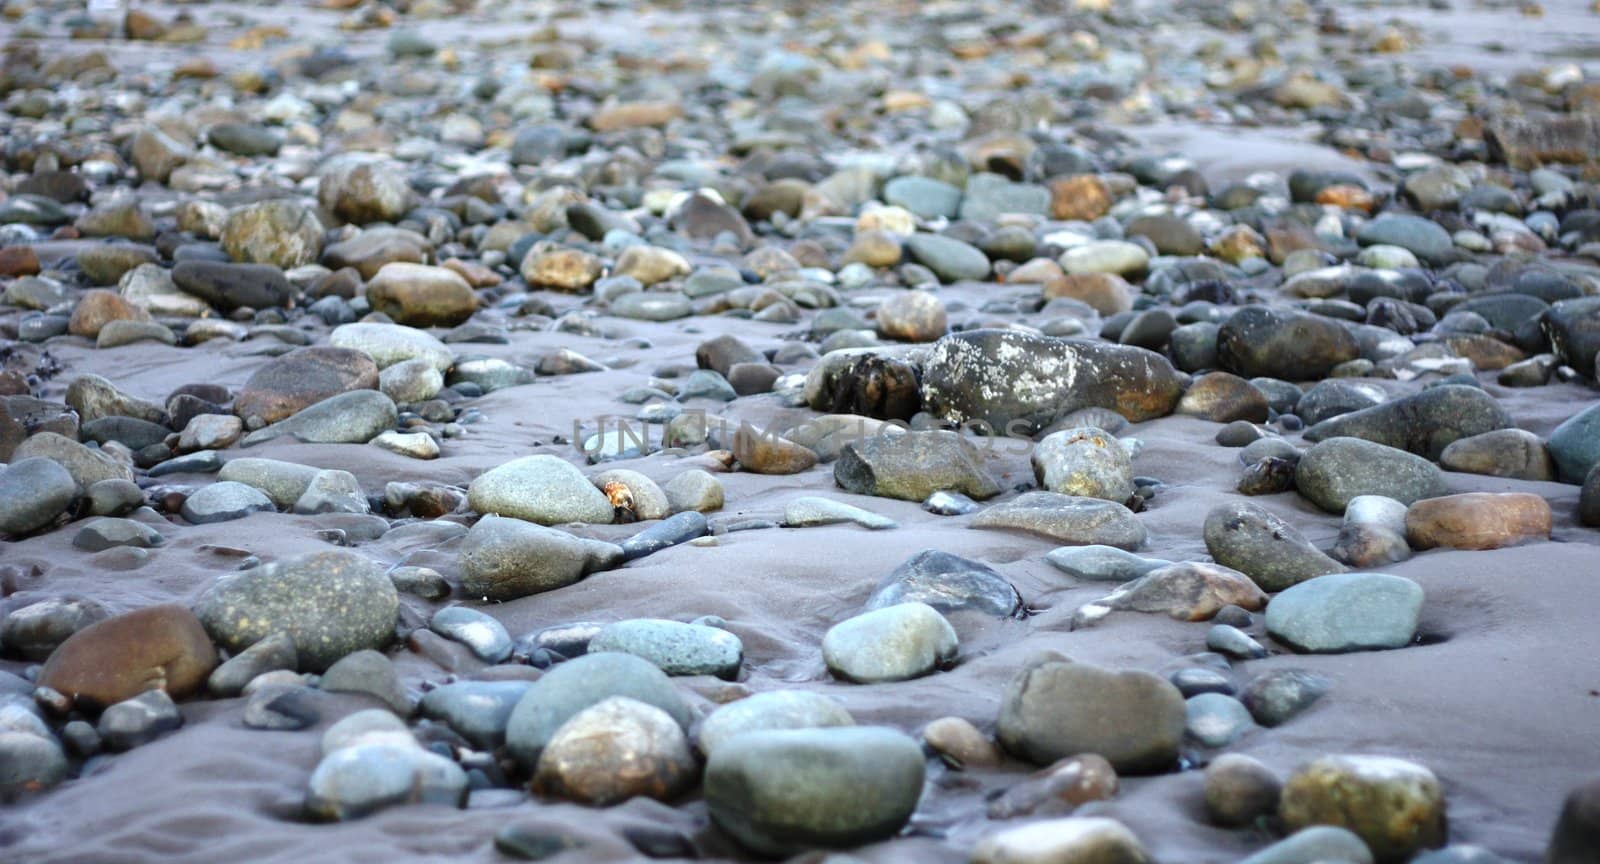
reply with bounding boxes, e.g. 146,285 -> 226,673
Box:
1306,384 -> 1514,459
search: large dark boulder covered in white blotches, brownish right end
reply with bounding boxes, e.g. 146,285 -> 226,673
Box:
922,330 -> 1182,435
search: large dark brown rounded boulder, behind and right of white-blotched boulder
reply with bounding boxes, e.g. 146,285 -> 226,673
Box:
1216,306 -> 1362,381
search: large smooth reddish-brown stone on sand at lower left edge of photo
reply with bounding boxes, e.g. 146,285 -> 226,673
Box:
38,605 -> 216,707
